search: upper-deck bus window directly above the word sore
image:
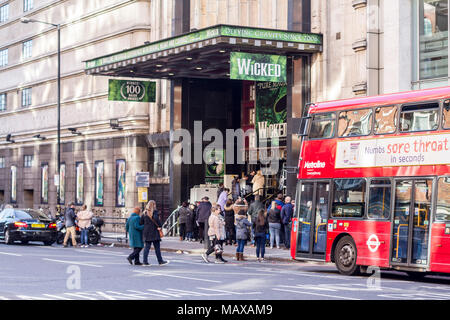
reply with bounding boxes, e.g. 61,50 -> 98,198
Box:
400,103 -> 439,132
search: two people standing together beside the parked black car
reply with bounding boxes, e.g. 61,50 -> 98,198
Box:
63,202 -> 94,248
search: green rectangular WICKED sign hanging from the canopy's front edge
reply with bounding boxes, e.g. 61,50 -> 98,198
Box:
230,52 -> 287,82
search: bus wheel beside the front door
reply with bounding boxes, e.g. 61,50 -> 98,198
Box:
334,236 -> 359,276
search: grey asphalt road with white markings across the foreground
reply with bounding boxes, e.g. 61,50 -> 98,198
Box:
0,243 -> 450,300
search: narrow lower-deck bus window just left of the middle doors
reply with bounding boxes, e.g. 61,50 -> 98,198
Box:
367,180 -> 391,219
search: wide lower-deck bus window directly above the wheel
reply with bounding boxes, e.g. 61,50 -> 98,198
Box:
332,179 -> 366,218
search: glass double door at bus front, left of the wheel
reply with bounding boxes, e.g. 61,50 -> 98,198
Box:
297,182 -> 330,258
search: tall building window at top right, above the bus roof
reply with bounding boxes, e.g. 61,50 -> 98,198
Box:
418,0 -> 448,80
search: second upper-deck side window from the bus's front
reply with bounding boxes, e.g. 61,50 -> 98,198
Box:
338,109 -> 372,137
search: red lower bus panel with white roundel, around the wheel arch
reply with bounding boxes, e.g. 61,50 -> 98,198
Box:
326,220 -> 391,268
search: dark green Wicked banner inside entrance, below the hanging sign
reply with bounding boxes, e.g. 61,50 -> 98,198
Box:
255,82 -> 287,146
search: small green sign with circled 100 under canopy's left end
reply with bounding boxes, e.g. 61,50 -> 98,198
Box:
108,79 -> 156,102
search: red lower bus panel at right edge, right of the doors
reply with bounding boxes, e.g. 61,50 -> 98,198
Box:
430,223 -> 450,273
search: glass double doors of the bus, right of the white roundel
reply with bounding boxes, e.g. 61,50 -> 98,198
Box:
391,179 -> 433,266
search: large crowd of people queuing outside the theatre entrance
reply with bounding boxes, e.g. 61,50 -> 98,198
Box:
179,185 -> 295,263
